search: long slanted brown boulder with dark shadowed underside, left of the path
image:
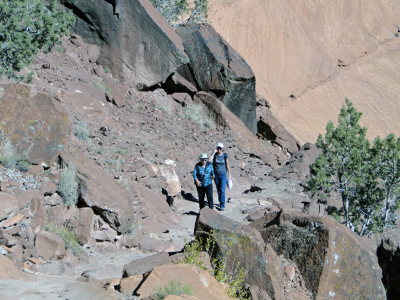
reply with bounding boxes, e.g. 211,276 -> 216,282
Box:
60,136 -> 134,235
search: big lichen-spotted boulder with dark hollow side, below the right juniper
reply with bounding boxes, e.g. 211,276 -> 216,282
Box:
250,212 -> 386,299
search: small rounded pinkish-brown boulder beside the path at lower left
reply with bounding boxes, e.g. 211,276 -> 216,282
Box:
35,231 -> 66,259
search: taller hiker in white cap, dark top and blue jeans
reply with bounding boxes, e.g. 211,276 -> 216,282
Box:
208,143 -> 231,211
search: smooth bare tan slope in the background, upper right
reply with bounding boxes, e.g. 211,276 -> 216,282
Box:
209,0 -> 400,143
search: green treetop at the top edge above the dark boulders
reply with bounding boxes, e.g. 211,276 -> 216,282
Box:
150,0 -> 208,27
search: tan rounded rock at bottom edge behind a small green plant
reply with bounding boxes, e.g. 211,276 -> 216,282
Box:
137,264 -> 231,300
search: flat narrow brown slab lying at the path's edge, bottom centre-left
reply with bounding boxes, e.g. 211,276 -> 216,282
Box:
122,252 -> 171,278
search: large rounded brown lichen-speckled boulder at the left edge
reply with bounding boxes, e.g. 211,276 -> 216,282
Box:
0,84 -> 71,165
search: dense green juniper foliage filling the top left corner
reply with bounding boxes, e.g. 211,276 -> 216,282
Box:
0,0 -> 75,80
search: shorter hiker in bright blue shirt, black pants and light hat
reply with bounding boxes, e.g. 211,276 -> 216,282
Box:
193,153 -> 215,209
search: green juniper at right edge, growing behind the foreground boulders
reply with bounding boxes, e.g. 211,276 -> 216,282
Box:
308,99 -> 400,235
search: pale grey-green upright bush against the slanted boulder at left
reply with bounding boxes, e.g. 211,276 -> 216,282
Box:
57,163 -> 78,207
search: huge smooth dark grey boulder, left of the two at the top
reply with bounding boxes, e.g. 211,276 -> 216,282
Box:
61,0 -> 188,88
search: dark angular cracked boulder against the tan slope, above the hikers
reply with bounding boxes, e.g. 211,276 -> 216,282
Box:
176,24 -> 257,134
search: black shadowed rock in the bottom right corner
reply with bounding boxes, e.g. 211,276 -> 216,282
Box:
377,226 -> 400,300
